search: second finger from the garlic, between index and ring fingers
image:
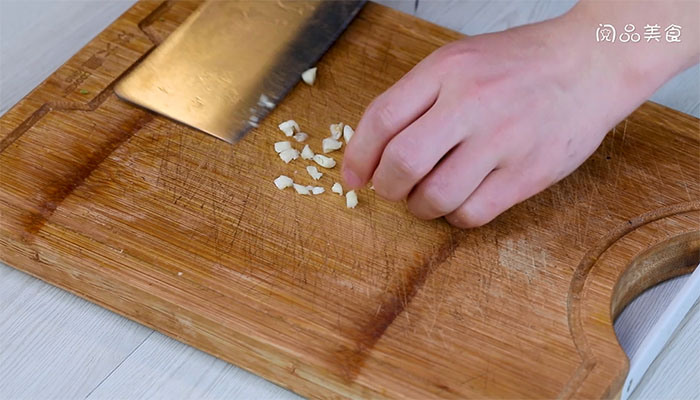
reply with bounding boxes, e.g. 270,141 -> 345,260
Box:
372,100 -> 469,201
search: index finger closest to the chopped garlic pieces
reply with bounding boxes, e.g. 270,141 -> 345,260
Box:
343,60 -> 440,189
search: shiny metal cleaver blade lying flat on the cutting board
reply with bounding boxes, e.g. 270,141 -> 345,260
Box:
115,0 -> 365,143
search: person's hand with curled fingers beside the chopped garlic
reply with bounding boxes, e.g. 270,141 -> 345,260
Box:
343,7 -> 688,228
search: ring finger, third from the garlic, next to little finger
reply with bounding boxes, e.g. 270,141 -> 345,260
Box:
408,137 -> 498,219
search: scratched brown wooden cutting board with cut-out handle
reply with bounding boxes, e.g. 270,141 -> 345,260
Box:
0,1 -> 700,398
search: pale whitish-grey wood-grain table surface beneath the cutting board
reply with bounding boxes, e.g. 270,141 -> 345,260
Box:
0,0 -> 700,399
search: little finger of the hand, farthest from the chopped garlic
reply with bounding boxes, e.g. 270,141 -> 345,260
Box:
445,167 -> 553,228
